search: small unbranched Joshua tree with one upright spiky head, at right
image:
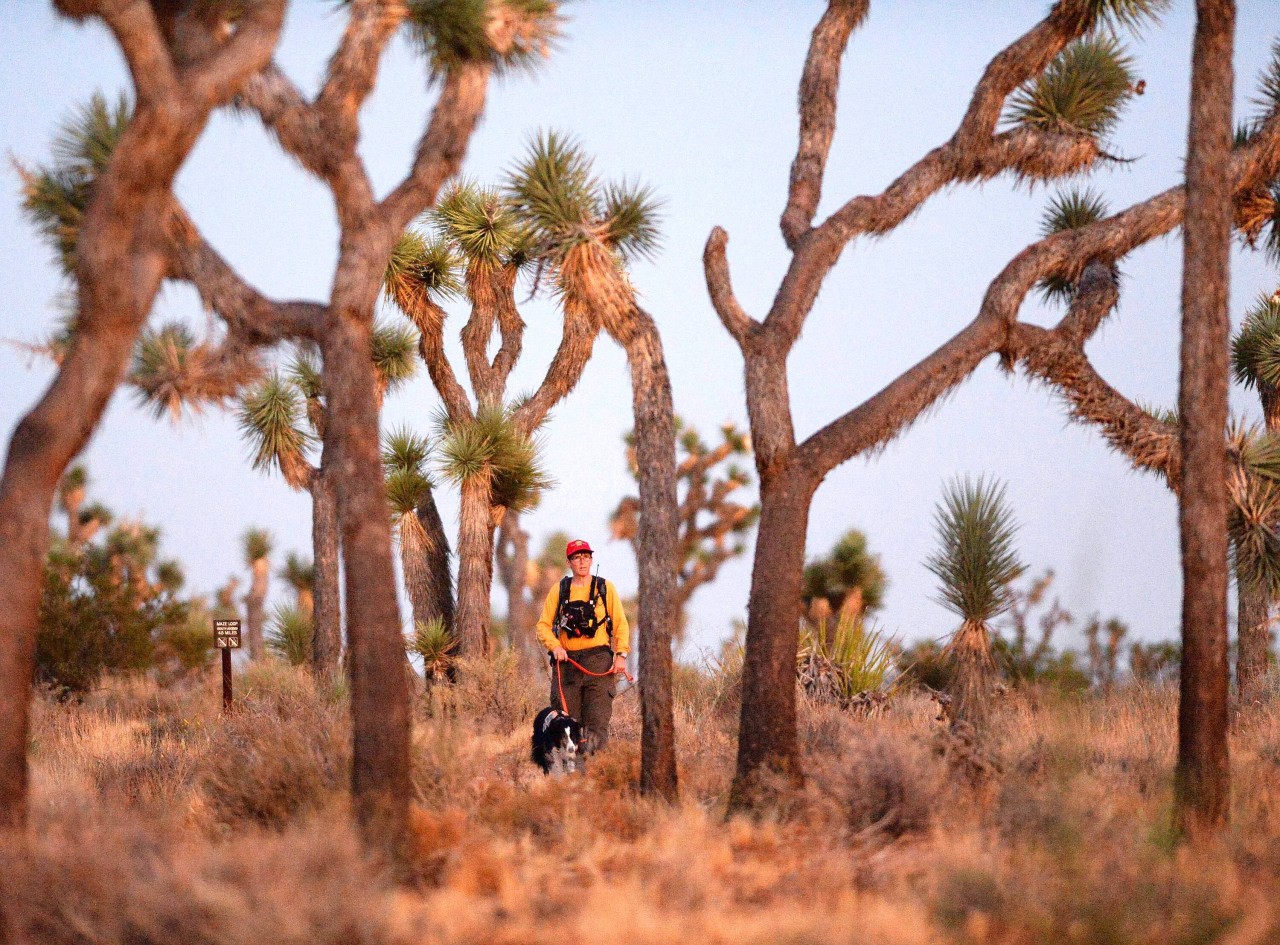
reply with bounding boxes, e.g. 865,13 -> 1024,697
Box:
925,478 -> 1025,731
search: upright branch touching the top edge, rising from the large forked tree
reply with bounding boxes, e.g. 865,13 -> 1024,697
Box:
781,0 -> 870,250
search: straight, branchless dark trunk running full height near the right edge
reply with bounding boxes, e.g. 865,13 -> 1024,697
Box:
1176,0 -> 1235,828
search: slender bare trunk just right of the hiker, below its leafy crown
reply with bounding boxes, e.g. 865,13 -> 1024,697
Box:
604,306 -> 680,800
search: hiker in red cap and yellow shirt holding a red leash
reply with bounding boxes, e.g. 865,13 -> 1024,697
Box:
538,539 -> 631,752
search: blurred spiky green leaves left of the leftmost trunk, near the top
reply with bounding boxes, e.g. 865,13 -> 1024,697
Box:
18,92 -> 133,275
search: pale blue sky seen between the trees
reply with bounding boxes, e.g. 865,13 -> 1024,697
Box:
0,0 -> 1280,652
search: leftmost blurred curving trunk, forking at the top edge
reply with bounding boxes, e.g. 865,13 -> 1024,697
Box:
0,0 -> 284,830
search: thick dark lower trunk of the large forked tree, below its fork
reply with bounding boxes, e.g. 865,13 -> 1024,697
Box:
728,467 -> 815,812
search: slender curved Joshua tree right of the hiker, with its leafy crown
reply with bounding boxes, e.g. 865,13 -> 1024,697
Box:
509,134 -> 680,799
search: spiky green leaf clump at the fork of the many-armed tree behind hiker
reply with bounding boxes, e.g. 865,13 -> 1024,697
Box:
436,407 -> 554,512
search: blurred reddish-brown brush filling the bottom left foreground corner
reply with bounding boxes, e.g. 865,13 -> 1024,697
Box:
0,809 -> 409,945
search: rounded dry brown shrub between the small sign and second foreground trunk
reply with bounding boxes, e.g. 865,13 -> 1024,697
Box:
201,665 -> 351,827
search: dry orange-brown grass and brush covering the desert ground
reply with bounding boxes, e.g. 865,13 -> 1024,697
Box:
0,661 -> 1280,945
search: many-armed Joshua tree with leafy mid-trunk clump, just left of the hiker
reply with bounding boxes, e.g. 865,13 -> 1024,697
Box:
384,172 -> 598,656
